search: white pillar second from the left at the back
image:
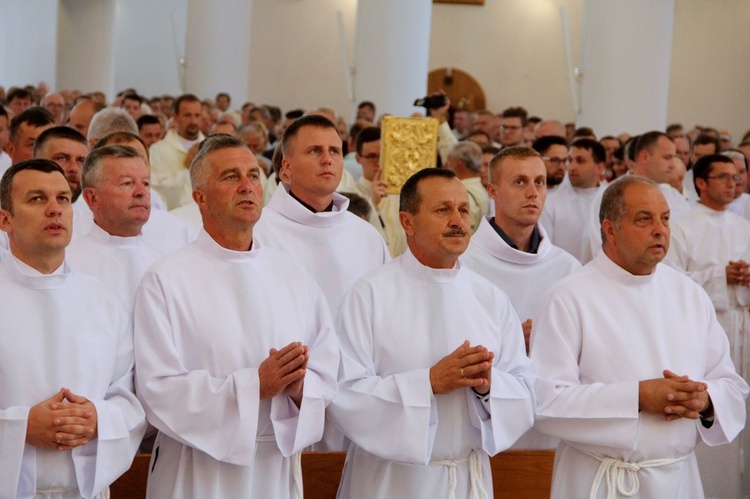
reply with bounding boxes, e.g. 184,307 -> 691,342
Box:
185,0 -> 253,102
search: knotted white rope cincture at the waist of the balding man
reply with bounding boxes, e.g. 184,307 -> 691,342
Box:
579,449 -> 690,499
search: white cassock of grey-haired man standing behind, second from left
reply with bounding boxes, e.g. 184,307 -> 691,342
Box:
65,224 -> 164,312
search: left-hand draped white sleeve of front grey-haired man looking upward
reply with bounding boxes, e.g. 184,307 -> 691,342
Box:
135,272 -> 260,466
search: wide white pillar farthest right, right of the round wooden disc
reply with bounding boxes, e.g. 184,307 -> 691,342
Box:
576,0 -> 674,136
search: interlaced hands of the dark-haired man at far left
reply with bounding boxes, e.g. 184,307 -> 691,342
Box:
26,388 -> 97,451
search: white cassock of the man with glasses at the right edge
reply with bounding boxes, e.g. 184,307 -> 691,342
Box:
666,203 -> 750,497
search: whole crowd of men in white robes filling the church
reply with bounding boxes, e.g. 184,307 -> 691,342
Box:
0,80 -> 750,499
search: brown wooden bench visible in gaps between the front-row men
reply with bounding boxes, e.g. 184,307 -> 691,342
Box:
110,450 -> 555,499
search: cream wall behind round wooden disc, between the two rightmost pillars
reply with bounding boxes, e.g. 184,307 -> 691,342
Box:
430,0 -> 582,121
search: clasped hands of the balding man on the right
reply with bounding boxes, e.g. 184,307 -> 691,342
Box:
638,369 -> 712,421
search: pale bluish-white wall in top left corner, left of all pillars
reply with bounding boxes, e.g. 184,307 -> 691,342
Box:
0,0 -> 57,90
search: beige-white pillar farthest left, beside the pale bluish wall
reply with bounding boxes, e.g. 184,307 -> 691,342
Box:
56,0 -> 115,100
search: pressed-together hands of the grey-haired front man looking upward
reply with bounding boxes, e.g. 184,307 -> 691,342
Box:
258,342 -> 310,407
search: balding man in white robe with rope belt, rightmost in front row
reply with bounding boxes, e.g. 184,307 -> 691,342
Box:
531,175 -> 750,498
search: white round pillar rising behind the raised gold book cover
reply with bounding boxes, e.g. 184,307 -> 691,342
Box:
354,0 -> 432,116
